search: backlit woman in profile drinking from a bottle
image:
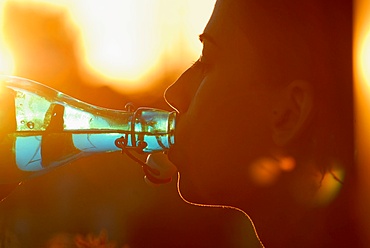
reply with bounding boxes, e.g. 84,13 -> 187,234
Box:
165,0 -> 358,247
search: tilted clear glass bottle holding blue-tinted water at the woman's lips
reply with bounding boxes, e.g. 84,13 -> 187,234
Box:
0,77 -> 175,183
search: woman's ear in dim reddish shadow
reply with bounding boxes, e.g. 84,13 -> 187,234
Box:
272,80 -> 314,146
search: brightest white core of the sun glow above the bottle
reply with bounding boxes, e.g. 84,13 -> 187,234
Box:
74,1 -> 161,82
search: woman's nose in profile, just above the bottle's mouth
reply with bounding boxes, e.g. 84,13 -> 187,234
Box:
164,65 -> 199,113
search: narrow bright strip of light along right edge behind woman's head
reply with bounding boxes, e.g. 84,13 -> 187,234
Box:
354,0 -> 370,244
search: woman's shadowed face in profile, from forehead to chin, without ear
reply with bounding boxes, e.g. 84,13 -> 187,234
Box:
165,2 -> 277,204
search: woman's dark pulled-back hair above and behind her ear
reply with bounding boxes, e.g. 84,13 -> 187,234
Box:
231,0 -> 354,178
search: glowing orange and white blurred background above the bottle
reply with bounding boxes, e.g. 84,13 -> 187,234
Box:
0,0 -> 215,107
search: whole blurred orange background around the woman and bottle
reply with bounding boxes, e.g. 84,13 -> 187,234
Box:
0,0 -> 370,248
